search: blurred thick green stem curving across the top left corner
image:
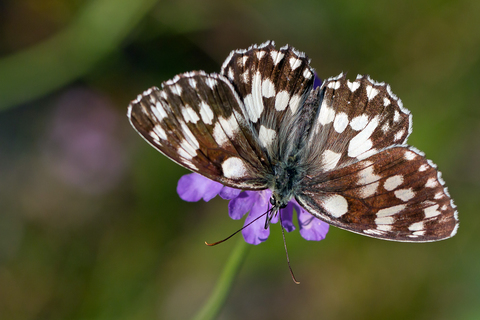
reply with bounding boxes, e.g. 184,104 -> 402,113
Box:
0,0 -> 157,111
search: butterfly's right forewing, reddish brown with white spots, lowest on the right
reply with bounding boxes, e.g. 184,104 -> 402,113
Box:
297,146 -> 458,242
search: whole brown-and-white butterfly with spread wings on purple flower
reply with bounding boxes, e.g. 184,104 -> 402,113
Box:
127,41 -> 458,242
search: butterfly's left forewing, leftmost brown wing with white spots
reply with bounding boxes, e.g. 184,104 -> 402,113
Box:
128,72 -> 266,189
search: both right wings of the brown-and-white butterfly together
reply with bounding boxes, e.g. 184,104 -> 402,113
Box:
296,75 -> 458,242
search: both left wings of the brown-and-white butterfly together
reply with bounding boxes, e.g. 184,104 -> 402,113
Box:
128,42 -> 314,189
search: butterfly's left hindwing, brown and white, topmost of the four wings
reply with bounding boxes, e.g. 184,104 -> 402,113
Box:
221,41 -> 315,164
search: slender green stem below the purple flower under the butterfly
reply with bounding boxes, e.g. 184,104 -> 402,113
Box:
193,237 -> 251,320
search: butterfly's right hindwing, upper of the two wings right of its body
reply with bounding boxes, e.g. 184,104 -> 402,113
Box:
305,74 -> 411,175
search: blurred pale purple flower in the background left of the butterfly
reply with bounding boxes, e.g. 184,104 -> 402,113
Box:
41,88 -> 126,194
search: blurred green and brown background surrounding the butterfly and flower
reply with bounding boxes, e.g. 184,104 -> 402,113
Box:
0,0 -> 480,320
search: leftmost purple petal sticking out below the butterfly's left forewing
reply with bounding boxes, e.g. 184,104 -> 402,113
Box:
177,173 -> 223,202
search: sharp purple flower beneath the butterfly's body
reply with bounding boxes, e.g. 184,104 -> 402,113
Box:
177,173 -> 329,244
